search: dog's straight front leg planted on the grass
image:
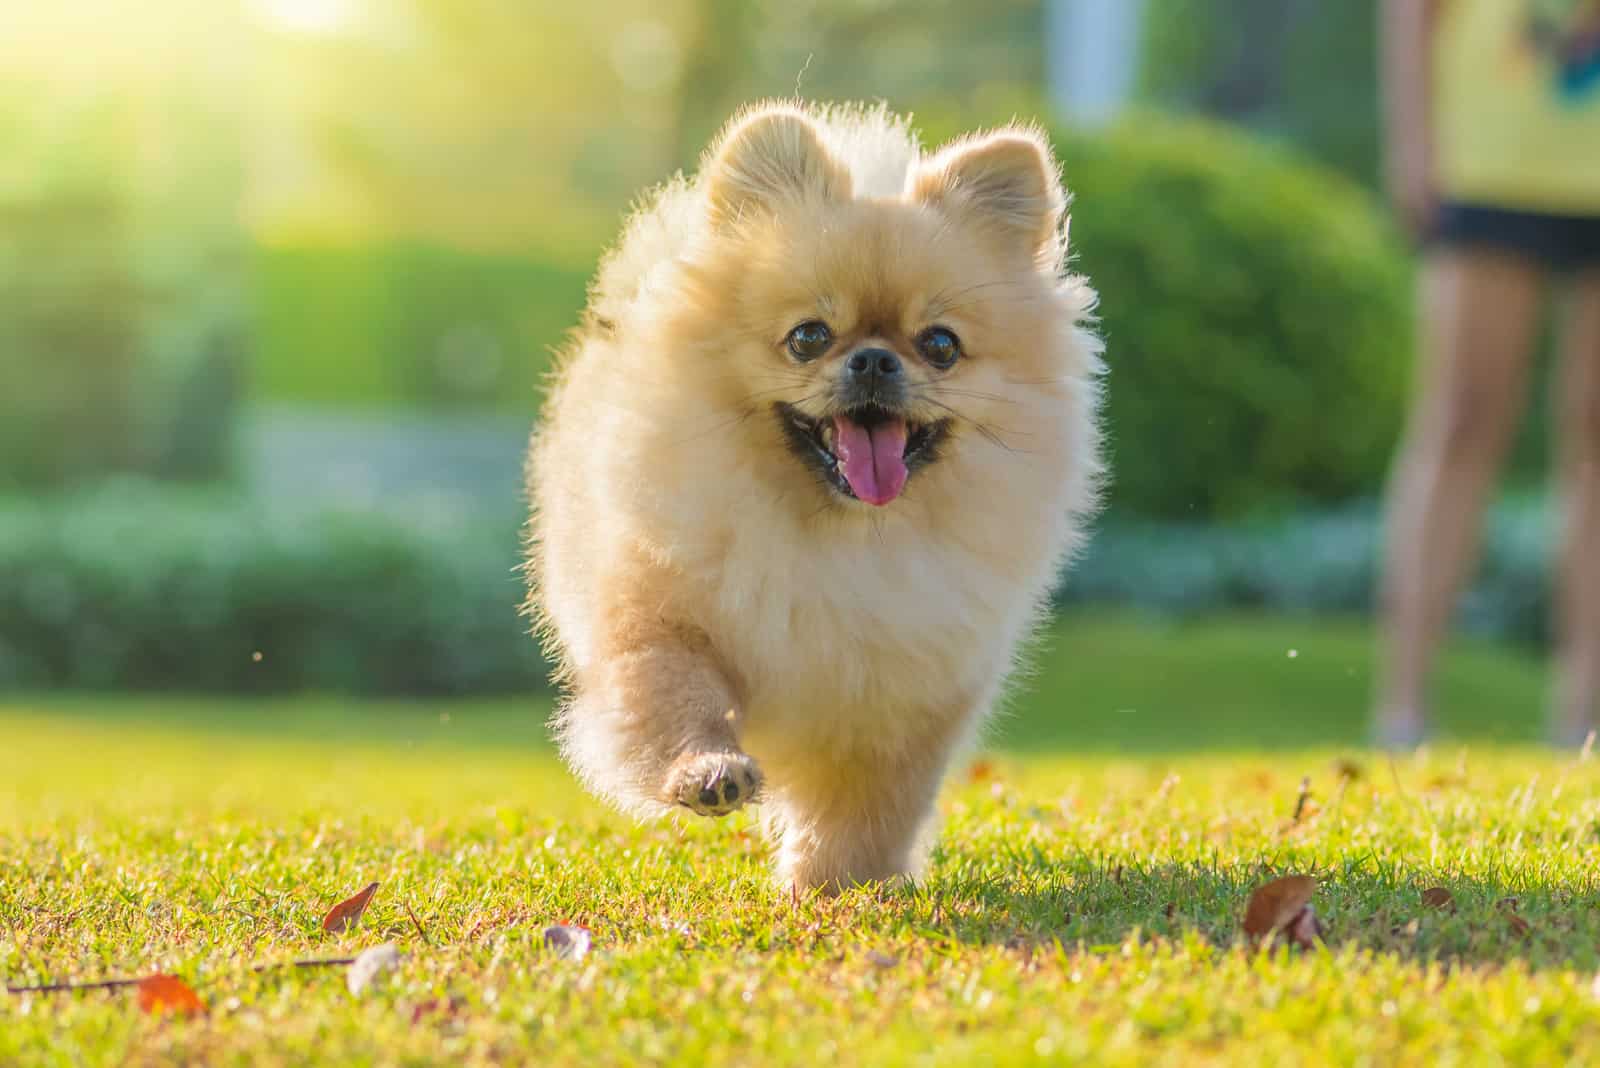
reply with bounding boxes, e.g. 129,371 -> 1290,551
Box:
768,725 -> 950,894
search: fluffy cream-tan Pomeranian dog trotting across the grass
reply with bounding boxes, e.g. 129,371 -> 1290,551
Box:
528,102 -> 1099,892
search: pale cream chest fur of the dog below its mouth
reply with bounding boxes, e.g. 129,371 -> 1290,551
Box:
675,505 -> 1032,748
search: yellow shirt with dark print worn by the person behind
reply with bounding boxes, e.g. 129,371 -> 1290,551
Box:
1434,0 -> 1600,214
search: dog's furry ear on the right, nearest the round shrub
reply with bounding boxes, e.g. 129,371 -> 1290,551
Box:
909,126 -> 1067,256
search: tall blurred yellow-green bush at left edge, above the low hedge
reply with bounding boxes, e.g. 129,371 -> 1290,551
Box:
0,98 -> 246,488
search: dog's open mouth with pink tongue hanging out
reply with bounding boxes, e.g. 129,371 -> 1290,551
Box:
774,403 -> 950,507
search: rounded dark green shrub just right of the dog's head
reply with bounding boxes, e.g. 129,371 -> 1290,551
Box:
1056,118 -> 1413,518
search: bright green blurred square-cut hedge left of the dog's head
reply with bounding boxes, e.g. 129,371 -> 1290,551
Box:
256,241 -> 589,412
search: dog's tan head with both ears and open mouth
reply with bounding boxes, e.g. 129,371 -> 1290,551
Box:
662,110 -> 1070,507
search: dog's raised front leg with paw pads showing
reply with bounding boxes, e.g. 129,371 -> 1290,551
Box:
560,624 -> 762,815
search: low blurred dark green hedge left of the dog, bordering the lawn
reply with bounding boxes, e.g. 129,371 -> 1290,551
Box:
0,481 -> 544,694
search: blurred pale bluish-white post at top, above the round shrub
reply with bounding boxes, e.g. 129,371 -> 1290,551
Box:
1045,0 -> 1144,125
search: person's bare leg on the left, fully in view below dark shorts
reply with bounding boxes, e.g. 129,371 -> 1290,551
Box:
1374,249 -> 1542,745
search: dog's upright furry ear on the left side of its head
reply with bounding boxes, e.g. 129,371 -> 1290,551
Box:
706,104 -> 850,225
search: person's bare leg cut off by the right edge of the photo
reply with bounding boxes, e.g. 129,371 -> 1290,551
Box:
1550,270 -> 1600,745
